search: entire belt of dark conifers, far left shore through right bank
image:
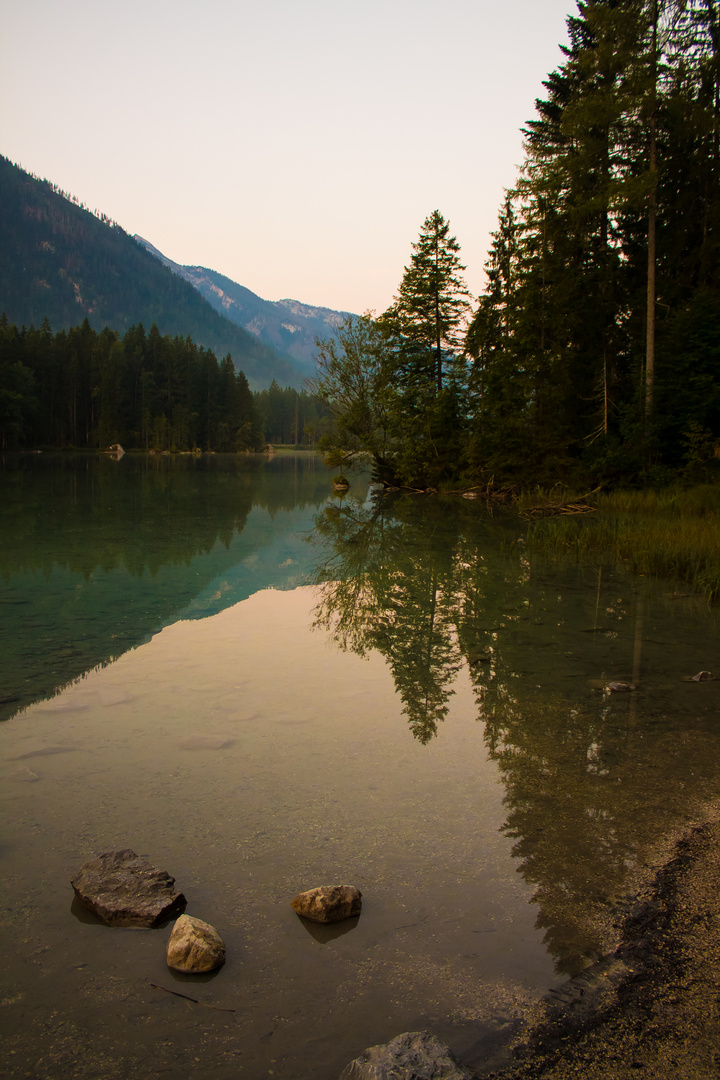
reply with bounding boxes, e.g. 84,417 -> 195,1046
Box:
0,0 -> 720,489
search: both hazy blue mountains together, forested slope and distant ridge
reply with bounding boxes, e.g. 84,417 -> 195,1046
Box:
0,157 -> 344,390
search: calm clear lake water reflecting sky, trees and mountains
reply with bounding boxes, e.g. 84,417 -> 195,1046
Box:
0,455 -> 720,1080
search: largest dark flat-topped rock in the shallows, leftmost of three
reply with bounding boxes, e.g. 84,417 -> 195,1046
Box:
70,848 -> 186,927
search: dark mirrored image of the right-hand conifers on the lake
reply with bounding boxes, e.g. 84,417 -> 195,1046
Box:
316,496 -> 720,974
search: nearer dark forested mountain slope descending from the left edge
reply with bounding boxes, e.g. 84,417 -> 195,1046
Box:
0,157 -> 302,389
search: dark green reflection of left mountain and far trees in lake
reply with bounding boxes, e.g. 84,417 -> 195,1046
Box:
0,455 -> 328,719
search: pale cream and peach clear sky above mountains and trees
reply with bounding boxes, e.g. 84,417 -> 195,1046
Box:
0,0 -> 576,312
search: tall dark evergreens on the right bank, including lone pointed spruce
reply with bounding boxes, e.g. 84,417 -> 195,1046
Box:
315,0 -> 720,487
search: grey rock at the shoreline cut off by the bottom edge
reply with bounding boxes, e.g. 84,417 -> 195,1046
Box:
340,1031 -> 473,1080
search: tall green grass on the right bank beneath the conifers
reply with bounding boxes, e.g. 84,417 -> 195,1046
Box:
525,484 -> 720,602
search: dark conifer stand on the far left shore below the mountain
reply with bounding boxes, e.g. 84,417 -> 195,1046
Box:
0,315 -> 263,451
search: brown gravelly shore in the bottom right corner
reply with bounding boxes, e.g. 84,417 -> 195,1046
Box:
472,807 -> 720,1080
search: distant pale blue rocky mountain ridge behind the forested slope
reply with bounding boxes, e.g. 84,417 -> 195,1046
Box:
135,235 -> 350,374
